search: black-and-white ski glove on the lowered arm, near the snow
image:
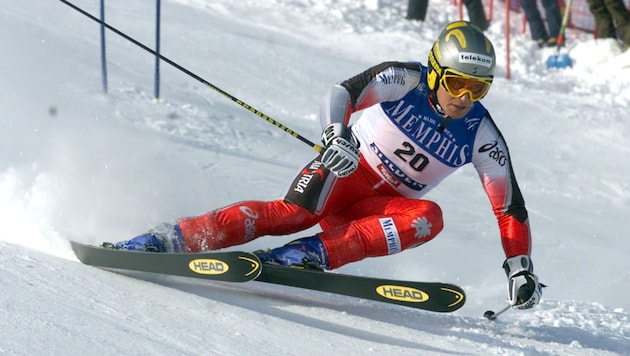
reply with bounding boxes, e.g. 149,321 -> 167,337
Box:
503,255 -> 544,309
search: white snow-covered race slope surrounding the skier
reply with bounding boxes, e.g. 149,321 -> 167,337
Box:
0,0 -> 630,355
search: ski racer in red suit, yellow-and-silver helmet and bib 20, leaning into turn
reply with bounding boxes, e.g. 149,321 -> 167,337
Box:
113,21 -> 542,309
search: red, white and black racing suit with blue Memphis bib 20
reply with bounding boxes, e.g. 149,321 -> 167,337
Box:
178,62 -> 531,269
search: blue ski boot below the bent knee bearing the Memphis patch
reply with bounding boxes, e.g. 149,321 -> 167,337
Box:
254,235 -> 328,271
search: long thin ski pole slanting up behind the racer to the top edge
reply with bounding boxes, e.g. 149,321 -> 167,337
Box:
59,0 -> 323,152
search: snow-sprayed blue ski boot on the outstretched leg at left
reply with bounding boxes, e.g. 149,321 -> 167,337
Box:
103,224 -> 186,252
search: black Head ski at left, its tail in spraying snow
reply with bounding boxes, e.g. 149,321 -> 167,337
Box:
70,241 -> 261,282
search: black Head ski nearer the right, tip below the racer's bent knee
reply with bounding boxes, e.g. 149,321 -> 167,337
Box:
256,264 -> 466,313
